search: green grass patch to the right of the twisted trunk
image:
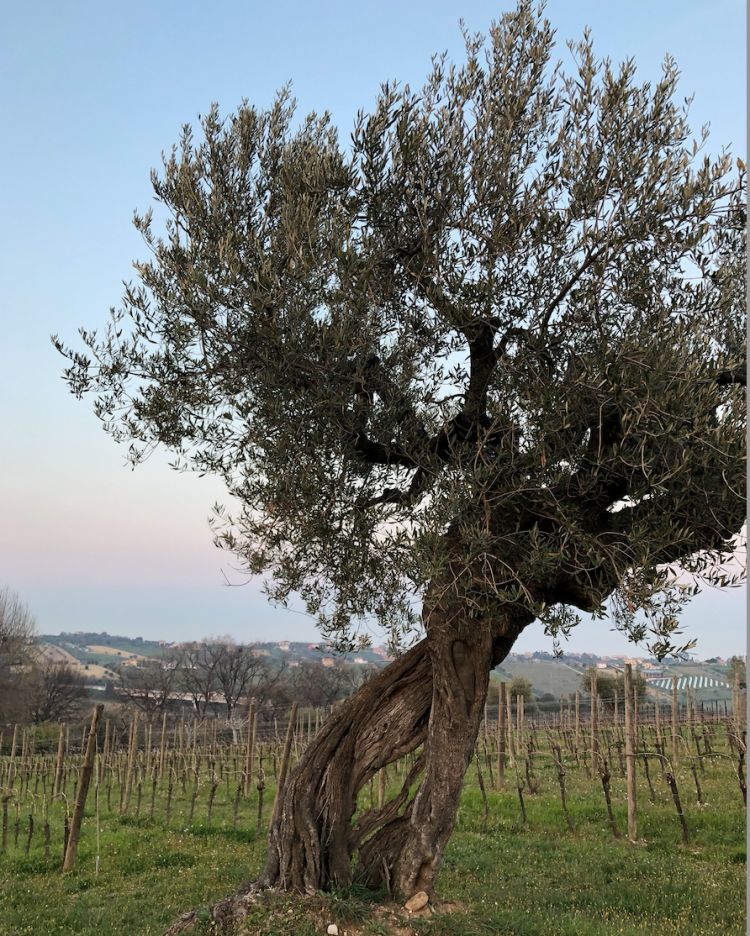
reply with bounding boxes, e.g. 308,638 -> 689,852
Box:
430,786 -> 745,936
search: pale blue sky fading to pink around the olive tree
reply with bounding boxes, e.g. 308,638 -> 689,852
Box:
0,0 -> 746,656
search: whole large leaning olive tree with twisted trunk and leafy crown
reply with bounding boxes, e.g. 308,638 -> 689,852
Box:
57,0 -> 745,916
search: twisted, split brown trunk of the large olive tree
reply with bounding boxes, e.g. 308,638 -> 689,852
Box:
169,595 -> 532,933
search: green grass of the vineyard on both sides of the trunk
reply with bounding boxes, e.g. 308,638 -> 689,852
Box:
0,740 -> 745,936
